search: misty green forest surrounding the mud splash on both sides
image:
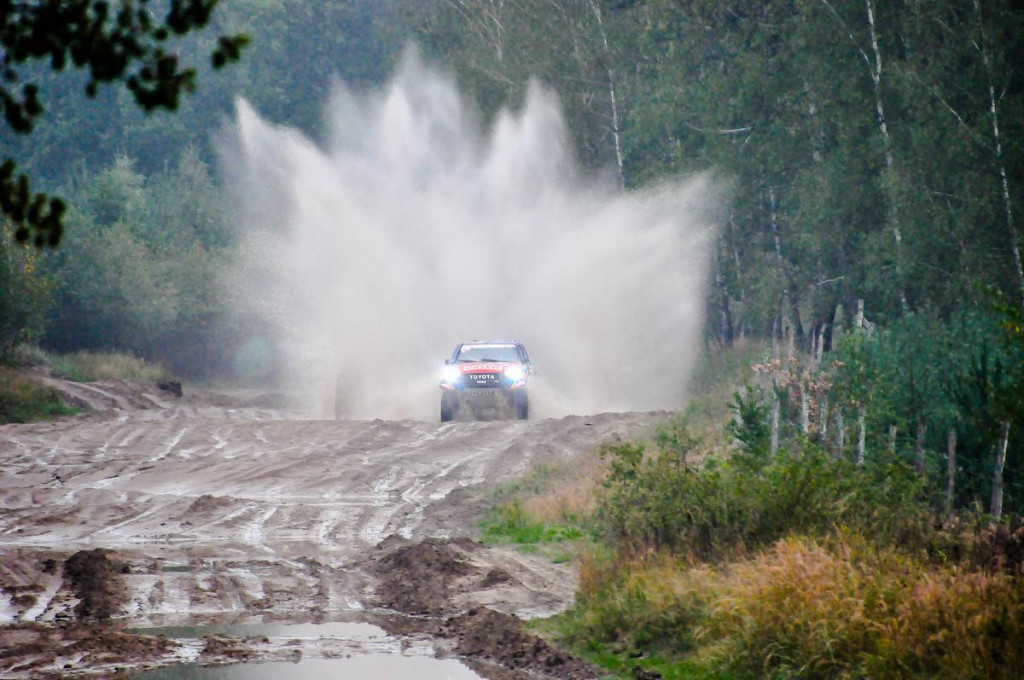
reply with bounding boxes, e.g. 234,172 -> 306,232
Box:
0,0 -> 1024,515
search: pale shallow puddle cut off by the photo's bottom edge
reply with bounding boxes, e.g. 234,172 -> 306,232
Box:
134,654 -> 482,680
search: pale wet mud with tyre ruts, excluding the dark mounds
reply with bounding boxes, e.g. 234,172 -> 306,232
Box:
0,395 -> 665,677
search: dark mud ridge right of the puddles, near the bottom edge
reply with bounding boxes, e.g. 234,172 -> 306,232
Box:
442,607 -> 600,680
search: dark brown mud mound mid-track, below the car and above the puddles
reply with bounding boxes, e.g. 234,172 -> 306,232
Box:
370,539 -> 479,617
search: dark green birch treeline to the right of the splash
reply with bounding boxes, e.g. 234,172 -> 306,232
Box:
417,0 -> 1024,333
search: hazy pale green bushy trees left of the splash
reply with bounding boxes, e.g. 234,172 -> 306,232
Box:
45,148 -> 229,376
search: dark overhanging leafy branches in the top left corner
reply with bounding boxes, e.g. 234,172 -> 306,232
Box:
0,0 -> 249,248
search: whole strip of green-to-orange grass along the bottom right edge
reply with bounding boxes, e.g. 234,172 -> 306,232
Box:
575,538 -> 1024,680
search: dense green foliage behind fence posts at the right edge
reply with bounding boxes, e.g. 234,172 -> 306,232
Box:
798,309 -> 1024,512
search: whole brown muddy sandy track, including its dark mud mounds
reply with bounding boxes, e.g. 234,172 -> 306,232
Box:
0,381 -> 665,678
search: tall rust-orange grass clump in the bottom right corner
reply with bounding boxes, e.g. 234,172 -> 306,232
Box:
705,539 -> 1024,680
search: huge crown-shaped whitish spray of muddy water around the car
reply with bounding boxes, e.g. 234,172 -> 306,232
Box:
221,54 -> 720,419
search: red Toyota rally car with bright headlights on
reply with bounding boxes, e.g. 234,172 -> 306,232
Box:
440,340 -> 534,423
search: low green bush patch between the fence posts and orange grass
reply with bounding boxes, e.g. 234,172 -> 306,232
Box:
596,421 -> 931,561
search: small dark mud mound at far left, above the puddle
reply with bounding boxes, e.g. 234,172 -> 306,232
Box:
63,548 -> 128,621
